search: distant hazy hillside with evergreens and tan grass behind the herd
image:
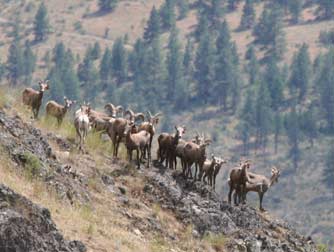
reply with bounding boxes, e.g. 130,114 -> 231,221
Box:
0,0 -> 334,246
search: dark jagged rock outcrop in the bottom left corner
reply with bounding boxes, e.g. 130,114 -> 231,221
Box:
0,184 -> 86,252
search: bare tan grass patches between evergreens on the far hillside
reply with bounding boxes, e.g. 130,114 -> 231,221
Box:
0,0 -> 334,248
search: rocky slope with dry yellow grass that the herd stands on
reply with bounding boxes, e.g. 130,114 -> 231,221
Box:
0,102 -> 316,251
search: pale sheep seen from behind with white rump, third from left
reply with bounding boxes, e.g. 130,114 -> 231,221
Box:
74,105 -> 90,151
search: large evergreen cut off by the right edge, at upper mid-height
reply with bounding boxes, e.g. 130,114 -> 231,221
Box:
317,49 -> 334,132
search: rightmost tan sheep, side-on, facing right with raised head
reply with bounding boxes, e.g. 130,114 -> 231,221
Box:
234,167 -> 281,211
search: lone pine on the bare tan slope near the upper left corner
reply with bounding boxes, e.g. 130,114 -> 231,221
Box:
34,2 -> 49,42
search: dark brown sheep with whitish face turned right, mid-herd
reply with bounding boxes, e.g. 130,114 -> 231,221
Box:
157,126 -> 186,168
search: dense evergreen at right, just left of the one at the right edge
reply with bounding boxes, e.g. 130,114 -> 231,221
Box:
289,43 -> 311,100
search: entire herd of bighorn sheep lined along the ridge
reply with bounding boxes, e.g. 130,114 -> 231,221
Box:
22,81 -> 280,211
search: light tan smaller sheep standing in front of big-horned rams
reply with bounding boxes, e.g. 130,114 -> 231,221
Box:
124,122 -> 151,169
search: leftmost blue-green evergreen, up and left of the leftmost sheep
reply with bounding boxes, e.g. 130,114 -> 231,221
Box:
7,42 -> 23,86
